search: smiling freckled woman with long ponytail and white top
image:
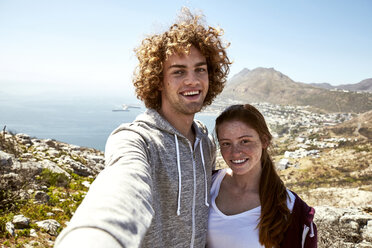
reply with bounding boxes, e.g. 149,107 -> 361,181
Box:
207,104 -> 317,248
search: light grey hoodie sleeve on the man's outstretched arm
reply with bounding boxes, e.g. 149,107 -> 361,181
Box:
55,130 -> 154,248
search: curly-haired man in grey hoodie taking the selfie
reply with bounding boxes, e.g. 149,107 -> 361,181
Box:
56,10 -> 230,248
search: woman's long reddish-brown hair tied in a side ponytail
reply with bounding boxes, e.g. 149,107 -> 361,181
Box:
216,104 -> 290,248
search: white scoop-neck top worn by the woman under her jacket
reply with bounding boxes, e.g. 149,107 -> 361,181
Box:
207,169 -> 295,248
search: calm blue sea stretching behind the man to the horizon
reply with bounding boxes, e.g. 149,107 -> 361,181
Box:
0,94 -> 216,151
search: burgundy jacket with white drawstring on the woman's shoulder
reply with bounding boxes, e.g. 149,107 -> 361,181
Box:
280,192 -> 318,248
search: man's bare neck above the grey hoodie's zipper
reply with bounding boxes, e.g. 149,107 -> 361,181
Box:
159,109 -> 195,144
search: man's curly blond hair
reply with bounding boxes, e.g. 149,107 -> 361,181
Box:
133,8 -> 231,110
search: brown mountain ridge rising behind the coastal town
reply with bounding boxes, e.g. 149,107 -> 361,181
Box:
220,67 -> 372,113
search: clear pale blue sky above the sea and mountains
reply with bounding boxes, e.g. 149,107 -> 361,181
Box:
0,0 -> 372,99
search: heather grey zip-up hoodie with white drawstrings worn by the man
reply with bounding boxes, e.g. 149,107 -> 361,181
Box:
55,110 -> 215,248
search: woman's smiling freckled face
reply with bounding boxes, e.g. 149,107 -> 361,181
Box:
217,120 -> 264,175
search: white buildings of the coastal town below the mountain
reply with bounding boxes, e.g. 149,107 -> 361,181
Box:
203,99 -> 357,170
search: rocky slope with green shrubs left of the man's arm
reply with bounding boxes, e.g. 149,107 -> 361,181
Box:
0,132 -> 104,247
